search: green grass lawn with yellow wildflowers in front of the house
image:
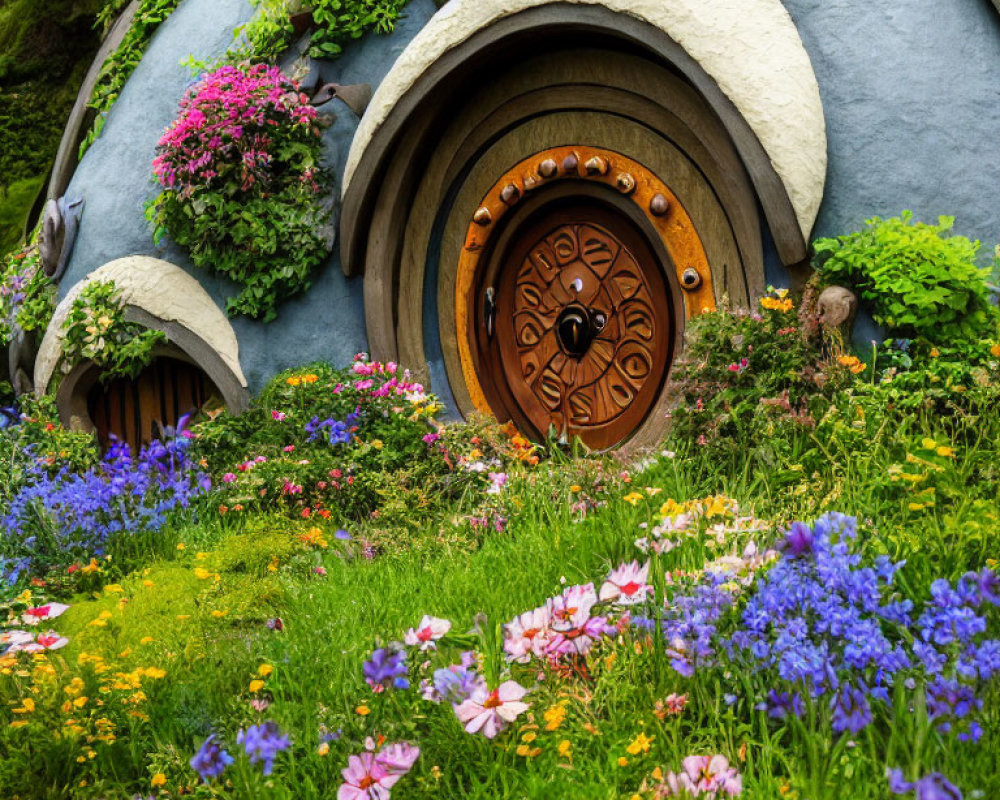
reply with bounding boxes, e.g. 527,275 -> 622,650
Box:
0,322 -> 1000,800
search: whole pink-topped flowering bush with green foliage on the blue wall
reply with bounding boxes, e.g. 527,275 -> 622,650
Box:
147,64 -> 332,322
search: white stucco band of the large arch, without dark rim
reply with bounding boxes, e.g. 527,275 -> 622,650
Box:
343,0 -> 827,241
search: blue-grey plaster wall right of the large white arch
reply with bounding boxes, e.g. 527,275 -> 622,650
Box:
784,0 -> 1000,245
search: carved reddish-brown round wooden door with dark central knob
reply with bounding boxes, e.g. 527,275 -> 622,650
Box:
480,200 -> 675,450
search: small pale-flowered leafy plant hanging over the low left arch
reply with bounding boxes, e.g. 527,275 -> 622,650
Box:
63,281 -> 167,381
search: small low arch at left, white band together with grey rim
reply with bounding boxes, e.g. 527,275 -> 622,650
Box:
35,256 -> 249,404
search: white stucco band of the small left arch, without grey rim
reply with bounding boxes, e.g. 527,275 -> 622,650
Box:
35,256 -> 247,395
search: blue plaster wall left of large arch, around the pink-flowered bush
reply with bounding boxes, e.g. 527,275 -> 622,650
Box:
60,0 -> 435,391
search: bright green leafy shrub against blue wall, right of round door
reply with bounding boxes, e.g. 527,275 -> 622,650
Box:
814,211 -> 997,345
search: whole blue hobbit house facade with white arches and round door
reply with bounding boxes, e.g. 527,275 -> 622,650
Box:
9,0 -> 1000,450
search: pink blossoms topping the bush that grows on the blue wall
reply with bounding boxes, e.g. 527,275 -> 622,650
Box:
153,64 -> 320,197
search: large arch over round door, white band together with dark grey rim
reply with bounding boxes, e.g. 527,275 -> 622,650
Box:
341,0 -> 826,275
